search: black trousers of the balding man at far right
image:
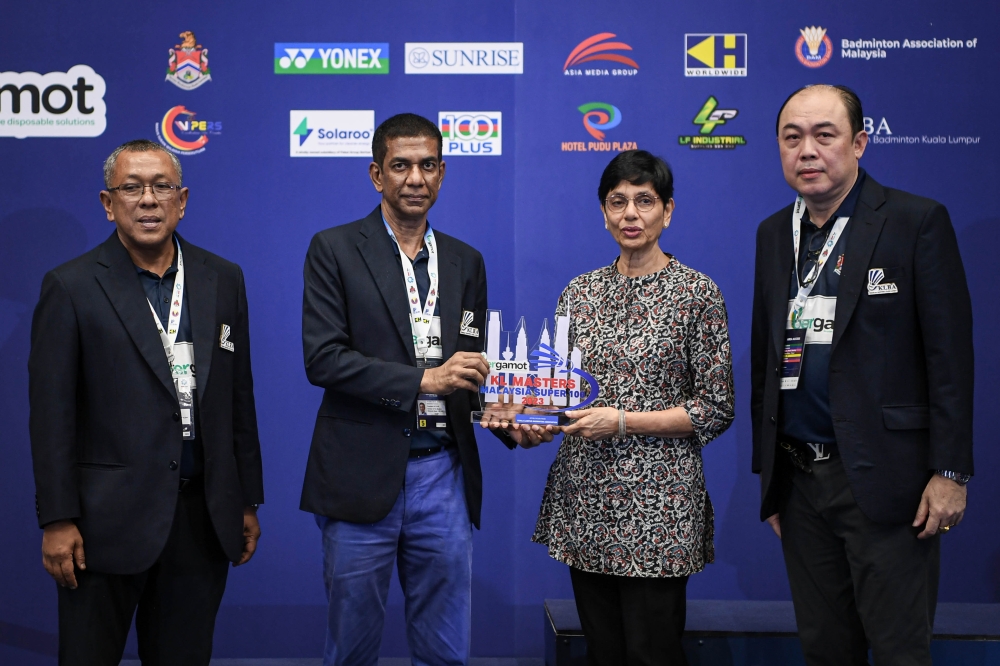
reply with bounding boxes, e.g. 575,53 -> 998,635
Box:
780,456 -> 941,666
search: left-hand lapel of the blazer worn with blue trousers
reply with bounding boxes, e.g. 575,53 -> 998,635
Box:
358,207 -> 417,365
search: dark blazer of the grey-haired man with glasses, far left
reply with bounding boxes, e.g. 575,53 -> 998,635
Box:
28,232 -> 264,574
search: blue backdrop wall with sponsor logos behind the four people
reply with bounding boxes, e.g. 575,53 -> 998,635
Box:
0,0 -> 1000,664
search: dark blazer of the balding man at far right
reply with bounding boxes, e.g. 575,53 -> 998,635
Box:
750,175 -> 973,524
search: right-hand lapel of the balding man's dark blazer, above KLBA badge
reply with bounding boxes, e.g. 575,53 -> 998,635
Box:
830,176 -> 885,354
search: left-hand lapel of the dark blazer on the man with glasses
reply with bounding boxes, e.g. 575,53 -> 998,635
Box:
97,231 -> 176,396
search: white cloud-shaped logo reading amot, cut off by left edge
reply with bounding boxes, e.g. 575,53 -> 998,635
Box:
0,65 -> 107,139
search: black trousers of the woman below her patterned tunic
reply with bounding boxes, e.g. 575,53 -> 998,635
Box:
569,567 -> 688,666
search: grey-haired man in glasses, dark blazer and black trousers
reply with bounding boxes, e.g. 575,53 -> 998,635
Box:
28,140 -> 264,666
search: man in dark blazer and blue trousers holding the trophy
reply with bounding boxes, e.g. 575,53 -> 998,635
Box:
301,114 -> 552,665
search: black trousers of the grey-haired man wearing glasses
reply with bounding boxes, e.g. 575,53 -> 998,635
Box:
58,483 -> 229,666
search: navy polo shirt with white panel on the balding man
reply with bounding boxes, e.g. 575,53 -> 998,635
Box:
779,169 -> 865,449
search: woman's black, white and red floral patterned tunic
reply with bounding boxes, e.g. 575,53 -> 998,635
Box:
532,255 -> 733,577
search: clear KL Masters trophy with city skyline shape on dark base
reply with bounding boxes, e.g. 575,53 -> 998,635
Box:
472,310 -> 599,425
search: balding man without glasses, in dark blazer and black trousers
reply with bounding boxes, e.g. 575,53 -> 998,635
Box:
750,86 -> 973,666
